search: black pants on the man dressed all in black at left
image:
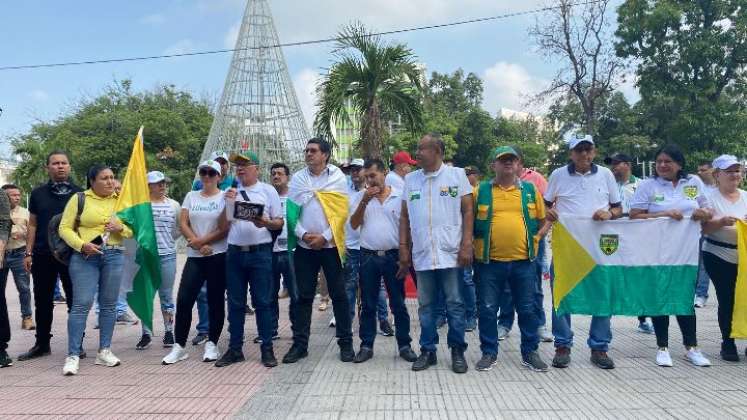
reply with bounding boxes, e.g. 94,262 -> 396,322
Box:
31,254 -> 73,347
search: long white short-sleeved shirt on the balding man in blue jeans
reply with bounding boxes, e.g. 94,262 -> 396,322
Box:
402,164 -> 470,271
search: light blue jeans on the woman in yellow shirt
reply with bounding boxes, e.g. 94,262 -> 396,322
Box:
67,249 -> 124,356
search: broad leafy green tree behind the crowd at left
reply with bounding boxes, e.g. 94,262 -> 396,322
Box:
12,80 -> 213,200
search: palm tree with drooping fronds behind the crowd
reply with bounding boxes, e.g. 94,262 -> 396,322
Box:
314,23 -> 423,158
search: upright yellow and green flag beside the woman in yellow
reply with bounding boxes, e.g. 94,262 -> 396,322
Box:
115,127 -> 161,330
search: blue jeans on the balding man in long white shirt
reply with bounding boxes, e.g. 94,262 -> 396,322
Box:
417,267 -> 467,352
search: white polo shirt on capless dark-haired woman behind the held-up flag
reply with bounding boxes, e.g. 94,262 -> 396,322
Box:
630,175 -> 711,216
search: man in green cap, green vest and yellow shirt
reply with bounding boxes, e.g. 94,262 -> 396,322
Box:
474,146 -> 547,372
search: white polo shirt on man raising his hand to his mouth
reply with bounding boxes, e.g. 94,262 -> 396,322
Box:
350,187 -> 402,251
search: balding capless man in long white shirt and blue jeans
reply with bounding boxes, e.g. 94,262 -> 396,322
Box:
397,134 -> 474,373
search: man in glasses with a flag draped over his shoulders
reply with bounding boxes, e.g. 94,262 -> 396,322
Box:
283,138 -> 355,363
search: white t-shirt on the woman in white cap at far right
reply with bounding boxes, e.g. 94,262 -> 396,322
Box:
703,190 -> 747,264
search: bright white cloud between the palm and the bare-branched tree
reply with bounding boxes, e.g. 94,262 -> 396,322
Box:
482,61 -> 548,114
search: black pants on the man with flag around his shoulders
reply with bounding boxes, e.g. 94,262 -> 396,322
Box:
293,246 -> 353,349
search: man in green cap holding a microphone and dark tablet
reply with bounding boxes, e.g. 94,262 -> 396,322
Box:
215,151 -> 283,367
